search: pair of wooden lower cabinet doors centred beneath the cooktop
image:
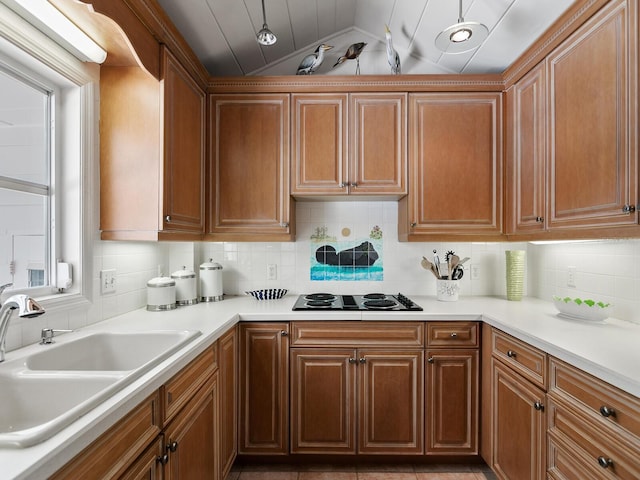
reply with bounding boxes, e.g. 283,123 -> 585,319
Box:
291,348 -> 424,454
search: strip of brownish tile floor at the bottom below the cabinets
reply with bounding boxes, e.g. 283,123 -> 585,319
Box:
226,465 -> 496,480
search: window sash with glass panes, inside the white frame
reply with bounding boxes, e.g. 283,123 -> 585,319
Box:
0,63 -> 55,289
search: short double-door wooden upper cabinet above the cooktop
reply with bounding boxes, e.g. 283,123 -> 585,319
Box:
292,93 -> 407,196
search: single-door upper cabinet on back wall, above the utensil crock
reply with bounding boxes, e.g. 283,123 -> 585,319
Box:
398,92 -> 502,241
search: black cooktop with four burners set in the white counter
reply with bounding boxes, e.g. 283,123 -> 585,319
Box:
293,293 -> 422,312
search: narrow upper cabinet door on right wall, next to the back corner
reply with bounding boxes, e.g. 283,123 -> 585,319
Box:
505,63 -> 546,234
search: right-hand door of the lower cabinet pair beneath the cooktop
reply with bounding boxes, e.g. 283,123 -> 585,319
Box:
358,349 -> 424,454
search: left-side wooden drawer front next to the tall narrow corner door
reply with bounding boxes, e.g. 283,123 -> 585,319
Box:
162,343 -> 218,425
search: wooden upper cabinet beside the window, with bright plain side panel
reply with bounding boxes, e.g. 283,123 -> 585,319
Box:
100,48 -> 205,240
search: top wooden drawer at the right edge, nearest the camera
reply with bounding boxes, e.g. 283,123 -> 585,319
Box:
549,358 -> 640,444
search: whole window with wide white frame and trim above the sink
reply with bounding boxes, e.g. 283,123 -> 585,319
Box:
0,0 -> 104,312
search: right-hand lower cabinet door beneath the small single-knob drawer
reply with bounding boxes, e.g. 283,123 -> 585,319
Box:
491,360 -> 546,480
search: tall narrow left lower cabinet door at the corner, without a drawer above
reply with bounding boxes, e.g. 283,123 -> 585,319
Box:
218,326 -> 238,479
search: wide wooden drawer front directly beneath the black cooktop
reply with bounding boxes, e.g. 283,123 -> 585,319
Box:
291,322 -> 424,347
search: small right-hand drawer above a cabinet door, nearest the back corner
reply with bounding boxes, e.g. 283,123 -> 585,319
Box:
491,328 -> 547,391
